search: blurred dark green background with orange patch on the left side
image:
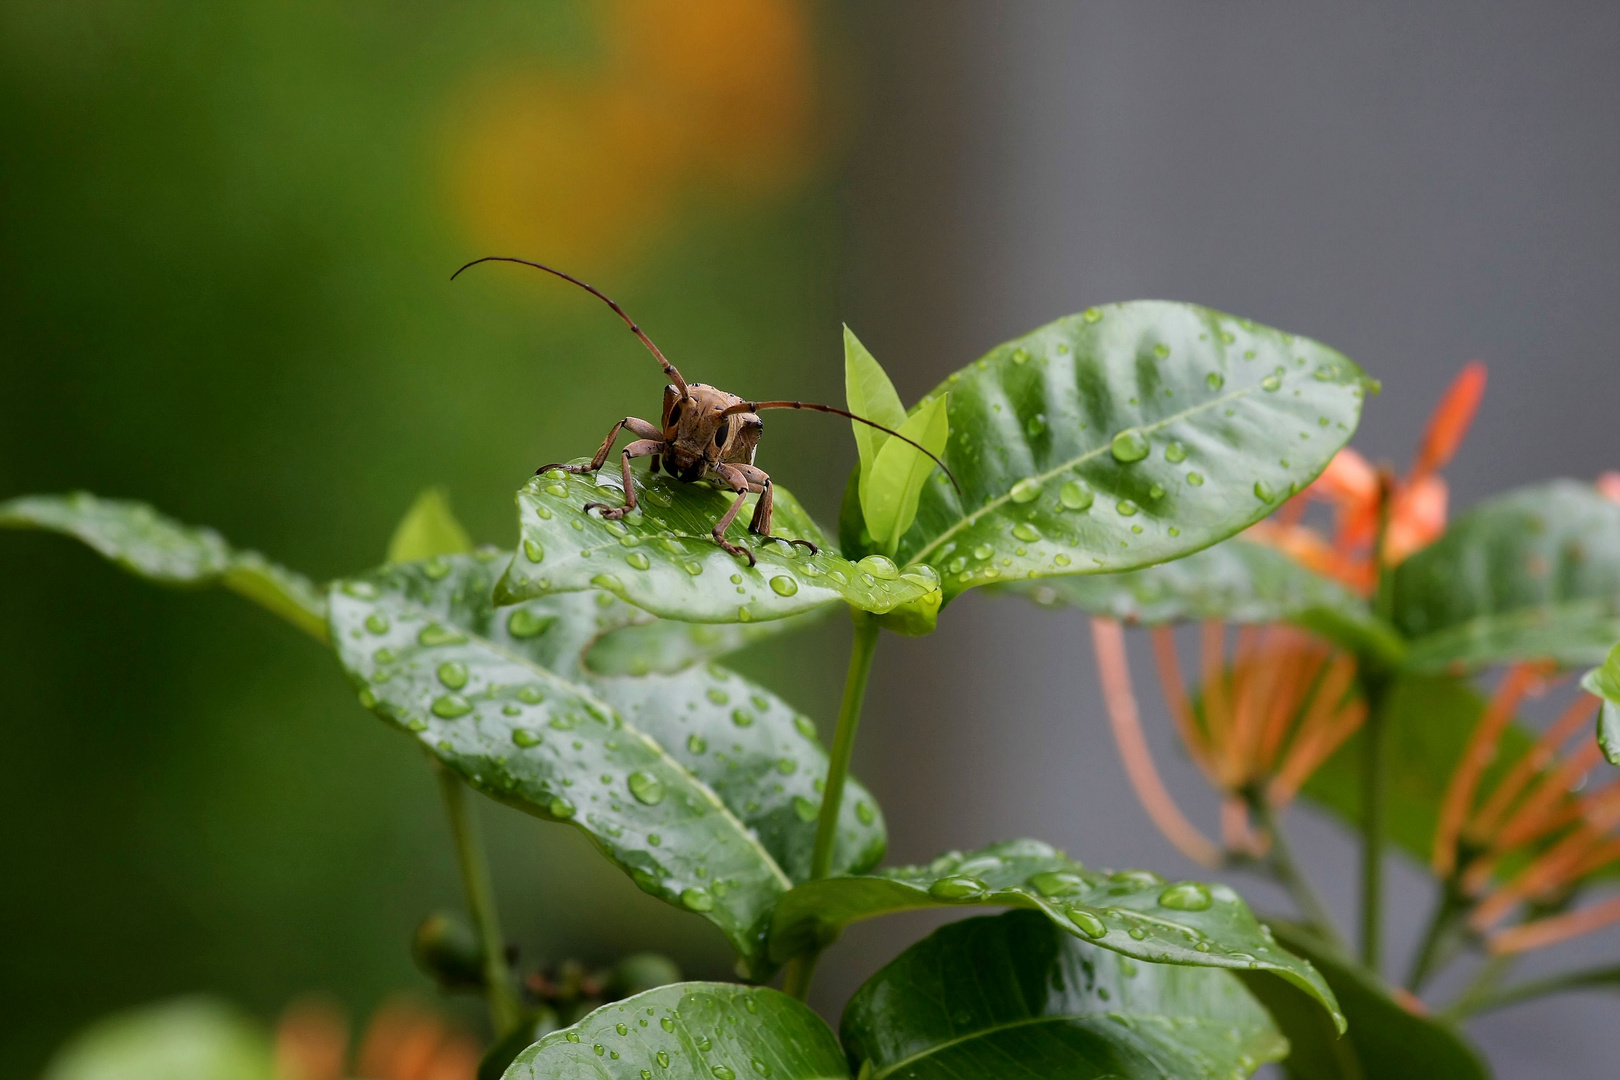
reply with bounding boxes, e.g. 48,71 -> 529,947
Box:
0,0 -> 852,1075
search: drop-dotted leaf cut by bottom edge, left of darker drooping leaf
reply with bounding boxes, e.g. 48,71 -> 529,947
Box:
505,983 -> 849,1080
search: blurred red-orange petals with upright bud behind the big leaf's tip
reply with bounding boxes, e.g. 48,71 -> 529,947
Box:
1249,361 -> 1486,593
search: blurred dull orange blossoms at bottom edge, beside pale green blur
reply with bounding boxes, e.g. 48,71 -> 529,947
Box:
275,997 -> 478,1080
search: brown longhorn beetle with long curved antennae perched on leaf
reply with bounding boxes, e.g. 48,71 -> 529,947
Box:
450,256 -> 962,567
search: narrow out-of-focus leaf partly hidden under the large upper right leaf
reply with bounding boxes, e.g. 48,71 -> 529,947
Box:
1009,538 -> 1403,657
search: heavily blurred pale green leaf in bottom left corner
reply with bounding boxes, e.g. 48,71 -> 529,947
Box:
42,997 -> 275,1080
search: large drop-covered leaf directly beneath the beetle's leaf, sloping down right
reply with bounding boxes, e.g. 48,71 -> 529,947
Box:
330,555 -> 883,975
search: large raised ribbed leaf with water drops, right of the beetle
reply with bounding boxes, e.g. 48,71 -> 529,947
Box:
839,301 -> 1364,599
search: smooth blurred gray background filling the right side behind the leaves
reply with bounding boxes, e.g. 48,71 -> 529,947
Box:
818,0 -> 1620,1080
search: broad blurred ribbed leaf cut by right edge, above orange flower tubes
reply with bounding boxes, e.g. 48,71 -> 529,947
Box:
1395,481 -> 1620,670
